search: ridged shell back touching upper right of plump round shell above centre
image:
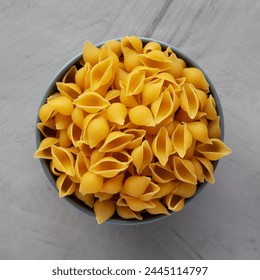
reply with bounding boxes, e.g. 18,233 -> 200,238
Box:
142,79 -> 163,106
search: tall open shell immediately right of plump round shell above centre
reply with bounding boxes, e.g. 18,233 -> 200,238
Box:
151,90 -> 174,124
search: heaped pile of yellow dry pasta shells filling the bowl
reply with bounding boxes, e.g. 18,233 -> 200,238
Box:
34,36 -> 231,224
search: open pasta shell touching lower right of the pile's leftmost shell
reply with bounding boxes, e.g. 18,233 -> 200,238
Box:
51,145 -> 75,176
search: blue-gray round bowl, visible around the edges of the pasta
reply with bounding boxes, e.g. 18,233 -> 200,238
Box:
36,37 -> 224,225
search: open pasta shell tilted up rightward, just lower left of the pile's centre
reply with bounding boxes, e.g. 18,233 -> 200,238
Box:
99,131 -> 134,152
